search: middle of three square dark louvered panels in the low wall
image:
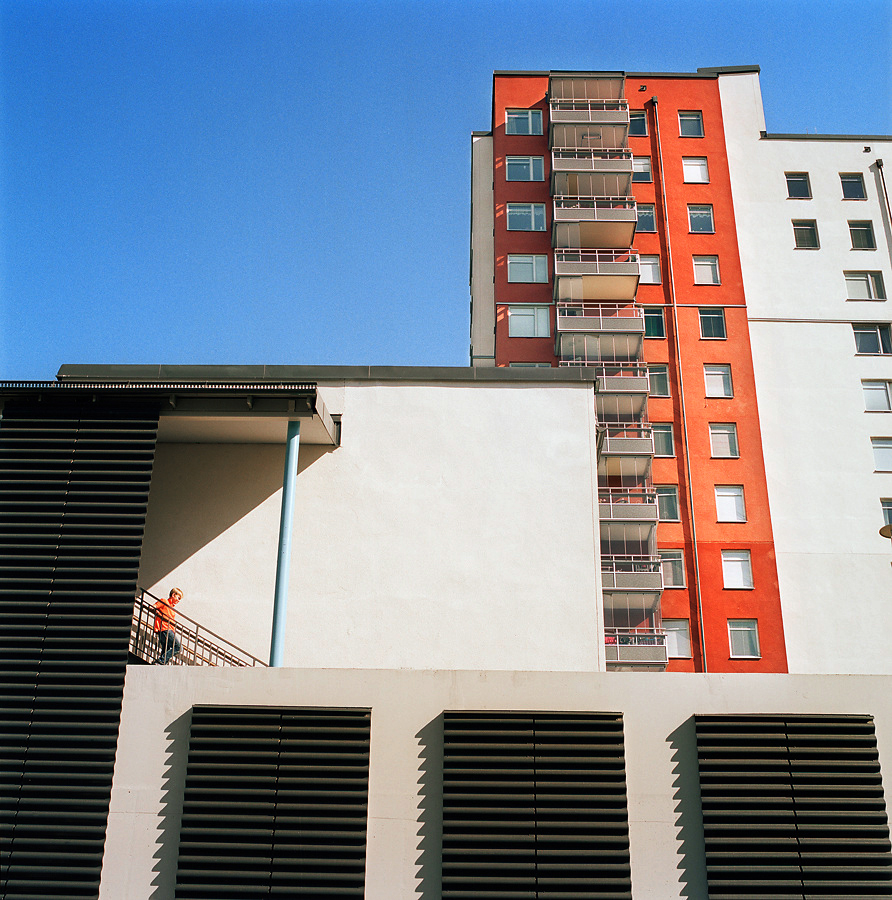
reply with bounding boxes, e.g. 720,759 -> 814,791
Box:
443,712 -> 632,900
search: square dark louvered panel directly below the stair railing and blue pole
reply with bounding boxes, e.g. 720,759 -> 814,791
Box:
177,706 -> 370,900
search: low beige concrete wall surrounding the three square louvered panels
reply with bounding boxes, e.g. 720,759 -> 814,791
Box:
100,666 -> 892,900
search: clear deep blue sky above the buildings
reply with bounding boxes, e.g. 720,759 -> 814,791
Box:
0,0 -> 892,379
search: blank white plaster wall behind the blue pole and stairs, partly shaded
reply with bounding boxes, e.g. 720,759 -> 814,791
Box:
140,383 -> 604,670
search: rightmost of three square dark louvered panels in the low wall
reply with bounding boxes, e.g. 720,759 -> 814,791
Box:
696,716 -> 892,900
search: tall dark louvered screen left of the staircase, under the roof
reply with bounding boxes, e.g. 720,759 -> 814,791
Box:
0,402 -> 158,900
